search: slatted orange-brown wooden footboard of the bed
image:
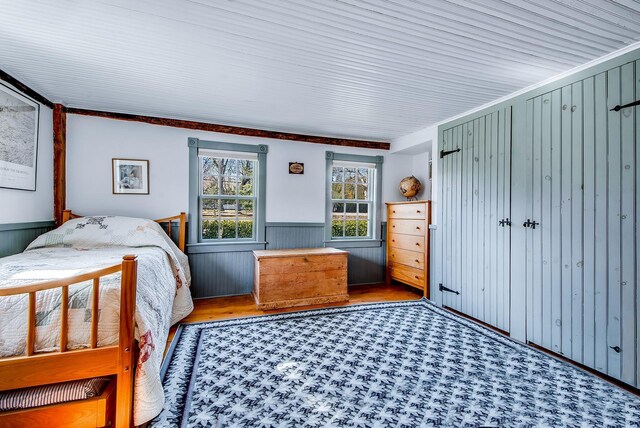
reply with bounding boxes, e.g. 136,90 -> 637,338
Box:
0,255 -> 138,428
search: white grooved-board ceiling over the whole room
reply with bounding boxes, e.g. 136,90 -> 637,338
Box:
0,0 -> 640,140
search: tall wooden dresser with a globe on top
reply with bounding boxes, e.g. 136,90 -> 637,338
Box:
386,201 -> 431,299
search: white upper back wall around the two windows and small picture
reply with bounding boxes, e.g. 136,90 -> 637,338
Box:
67,114 -> 413,223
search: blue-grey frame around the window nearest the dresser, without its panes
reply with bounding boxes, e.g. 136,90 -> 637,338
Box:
324,151 -> 384,248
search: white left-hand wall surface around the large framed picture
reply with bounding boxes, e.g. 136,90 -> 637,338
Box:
0,105 -> 53,224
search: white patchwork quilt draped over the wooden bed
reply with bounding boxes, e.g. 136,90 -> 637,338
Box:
0,217 -> 193,425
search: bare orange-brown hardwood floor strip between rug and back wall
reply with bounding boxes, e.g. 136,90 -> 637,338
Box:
165,284 -> 422,352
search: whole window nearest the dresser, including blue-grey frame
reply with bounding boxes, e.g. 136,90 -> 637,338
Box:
326,152 -> 382,241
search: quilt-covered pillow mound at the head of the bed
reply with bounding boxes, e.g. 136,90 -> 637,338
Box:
25,216 -> 191,284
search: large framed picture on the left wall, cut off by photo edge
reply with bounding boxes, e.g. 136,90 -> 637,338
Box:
0,82 -> 40,191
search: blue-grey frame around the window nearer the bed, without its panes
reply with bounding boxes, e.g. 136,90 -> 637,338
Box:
187,138 -> 269,253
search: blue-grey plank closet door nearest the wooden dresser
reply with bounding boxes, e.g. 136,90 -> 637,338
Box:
440,109 -> 511,330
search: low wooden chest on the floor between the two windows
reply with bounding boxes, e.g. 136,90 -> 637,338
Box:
253,248 -> 349,309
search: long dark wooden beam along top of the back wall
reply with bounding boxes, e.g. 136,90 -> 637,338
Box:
67,107 -> 390,150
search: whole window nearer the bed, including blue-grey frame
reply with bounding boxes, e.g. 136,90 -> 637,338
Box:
189,138 -> 267,249
